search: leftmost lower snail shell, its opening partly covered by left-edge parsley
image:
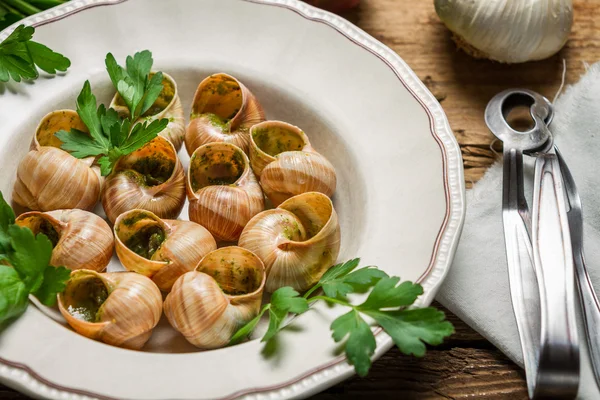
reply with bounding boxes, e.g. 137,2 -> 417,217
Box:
15,210 -> 114,272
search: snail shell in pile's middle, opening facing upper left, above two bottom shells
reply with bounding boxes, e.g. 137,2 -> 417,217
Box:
114,210 -> 217,292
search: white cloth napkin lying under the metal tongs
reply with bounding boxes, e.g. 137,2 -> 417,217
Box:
437,63 -> 600,399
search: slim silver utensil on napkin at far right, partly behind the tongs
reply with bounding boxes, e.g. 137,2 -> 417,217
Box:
554,146 -> 600,386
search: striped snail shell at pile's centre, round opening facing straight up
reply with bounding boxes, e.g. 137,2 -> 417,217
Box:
186,143 -> 264,241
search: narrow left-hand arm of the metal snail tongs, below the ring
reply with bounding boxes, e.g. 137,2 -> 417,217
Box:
502,148 -> 539,397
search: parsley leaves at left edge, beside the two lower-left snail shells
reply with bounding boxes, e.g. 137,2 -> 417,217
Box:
0,192 -> 71,325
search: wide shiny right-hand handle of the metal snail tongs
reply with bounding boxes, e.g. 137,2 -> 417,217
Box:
532,154 -> 579,398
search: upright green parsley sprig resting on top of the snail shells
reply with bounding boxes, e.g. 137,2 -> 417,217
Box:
55,50 -> 169,176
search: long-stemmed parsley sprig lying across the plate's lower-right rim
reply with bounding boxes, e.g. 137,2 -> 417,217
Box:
230,259 -> 454,376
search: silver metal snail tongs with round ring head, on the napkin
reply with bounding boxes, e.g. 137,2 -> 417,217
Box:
485,89 -> 579,399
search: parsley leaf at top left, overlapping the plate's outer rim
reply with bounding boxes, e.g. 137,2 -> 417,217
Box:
0,25 -> 71,82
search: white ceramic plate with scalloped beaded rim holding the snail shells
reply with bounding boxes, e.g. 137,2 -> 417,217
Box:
0,0 -> 465,399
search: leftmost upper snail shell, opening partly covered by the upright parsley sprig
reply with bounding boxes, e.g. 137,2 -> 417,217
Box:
12,110 -> 104,211
